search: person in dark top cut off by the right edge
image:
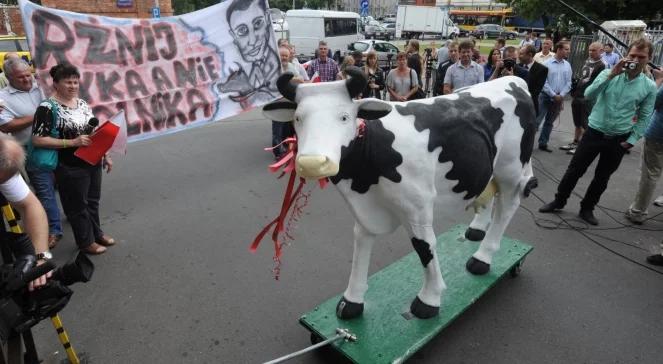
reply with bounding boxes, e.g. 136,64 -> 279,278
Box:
626,70 -> 663,225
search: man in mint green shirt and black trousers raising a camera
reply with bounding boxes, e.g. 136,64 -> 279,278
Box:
539,39 -> 656,225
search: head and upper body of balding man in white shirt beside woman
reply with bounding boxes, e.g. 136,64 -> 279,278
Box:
0,58 -> 44,145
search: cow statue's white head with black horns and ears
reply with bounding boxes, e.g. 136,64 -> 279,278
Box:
263,67 -> 391,179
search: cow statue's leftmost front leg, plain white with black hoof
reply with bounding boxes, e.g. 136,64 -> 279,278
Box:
336,222 -> 376,319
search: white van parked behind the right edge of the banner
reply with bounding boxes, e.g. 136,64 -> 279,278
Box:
285,10 -> 361,59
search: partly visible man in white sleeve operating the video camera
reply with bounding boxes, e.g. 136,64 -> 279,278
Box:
0,133 -> 52,291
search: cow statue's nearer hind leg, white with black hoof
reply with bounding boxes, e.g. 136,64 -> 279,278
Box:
465,181 -> 520,274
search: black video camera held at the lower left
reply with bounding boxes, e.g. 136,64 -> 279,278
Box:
0,237 -> 94,343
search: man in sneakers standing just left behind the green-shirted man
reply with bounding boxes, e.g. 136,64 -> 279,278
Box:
559,42 -> 605,154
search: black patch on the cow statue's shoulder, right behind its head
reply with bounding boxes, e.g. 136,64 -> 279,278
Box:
329,120 -> 403,193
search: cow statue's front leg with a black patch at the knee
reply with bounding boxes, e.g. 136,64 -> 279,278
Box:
408,224 -> 447,319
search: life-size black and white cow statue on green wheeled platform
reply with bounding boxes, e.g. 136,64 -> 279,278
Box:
263,67 -> 536,318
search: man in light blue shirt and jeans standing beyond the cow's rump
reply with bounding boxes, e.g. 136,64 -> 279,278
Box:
538,41 -> 573,153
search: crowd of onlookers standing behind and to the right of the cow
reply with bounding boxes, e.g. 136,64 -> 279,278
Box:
273,34 -> 663,265
